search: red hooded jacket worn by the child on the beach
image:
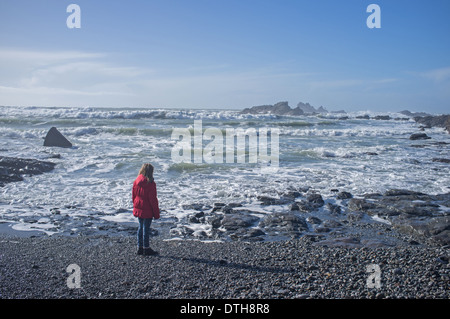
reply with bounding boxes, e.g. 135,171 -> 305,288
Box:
132,175 -> 159,219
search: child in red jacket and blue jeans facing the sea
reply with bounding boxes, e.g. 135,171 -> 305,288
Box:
132,164 -> 159,255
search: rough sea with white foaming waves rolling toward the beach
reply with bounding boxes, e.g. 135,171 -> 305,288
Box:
0,106 -> 450,237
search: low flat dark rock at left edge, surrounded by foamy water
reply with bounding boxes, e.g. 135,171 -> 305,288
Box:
0,156 -> 56,187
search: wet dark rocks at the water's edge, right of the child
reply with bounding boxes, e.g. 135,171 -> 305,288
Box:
170,189 -> 450,247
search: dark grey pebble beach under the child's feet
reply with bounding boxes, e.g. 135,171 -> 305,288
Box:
0,236 -> 450,299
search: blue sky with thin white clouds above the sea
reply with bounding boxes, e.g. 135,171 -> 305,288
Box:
0,0 -> 450,113
